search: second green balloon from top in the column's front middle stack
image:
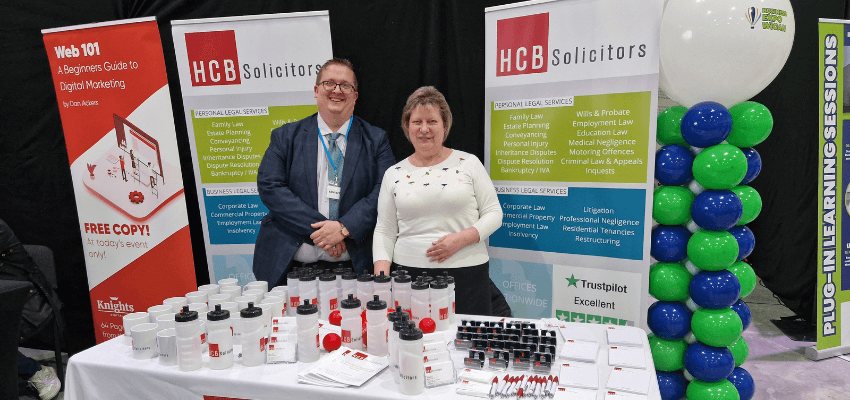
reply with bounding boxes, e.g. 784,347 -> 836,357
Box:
688,229 -> 738,271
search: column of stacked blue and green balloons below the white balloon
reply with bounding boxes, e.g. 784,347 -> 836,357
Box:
647,102 -> 773,400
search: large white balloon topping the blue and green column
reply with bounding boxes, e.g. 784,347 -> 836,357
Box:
659,0 -> 795,107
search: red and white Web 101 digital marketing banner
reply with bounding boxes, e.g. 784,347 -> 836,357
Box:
42,18 -> 195,343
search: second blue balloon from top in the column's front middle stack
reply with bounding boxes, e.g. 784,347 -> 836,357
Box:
691,190 -> 744,231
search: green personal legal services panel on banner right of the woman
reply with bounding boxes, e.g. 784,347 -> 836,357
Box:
490,92 -> 651,183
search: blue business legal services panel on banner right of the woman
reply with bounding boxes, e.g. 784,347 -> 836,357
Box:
490,188 -> 646,260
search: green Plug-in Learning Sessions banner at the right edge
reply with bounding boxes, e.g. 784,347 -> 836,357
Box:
806,19 -> 850,360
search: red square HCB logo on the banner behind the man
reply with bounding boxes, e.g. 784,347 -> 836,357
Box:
186,31 -> 242,86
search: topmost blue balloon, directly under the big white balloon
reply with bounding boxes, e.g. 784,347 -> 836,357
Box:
682,101 -> 732,147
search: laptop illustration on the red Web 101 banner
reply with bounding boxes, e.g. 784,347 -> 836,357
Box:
82,114 -> 183,220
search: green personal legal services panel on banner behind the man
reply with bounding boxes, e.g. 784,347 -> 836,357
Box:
192,105 -> 317,184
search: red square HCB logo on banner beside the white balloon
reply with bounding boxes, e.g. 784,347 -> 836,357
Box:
496,13 -> 549,76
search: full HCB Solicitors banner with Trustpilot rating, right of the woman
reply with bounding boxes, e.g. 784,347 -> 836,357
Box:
485,0 -> 662,326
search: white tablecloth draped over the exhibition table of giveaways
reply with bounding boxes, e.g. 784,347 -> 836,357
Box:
65,315 -> 661,400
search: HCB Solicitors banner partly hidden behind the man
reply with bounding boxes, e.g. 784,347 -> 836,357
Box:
171,11 -> 333,285
